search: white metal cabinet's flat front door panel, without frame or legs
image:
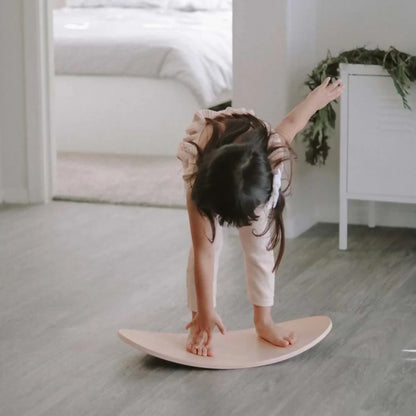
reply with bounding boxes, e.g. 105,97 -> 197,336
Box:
347,75 -> 416,200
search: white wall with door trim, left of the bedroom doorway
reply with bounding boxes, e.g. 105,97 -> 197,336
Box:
0,0 -> 53,203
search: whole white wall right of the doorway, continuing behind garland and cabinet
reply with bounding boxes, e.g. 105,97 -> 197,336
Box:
233,0 -> 416,237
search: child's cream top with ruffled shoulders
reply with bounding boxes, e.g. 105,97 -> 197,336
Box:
176,107 -> 283,186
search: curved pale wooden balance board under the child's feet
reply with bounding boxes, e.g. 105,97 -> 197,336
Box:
118,316 -> 332,369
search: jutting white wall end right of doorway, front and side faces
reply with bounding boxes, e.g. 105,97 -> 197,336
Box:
233,0 -> 316,237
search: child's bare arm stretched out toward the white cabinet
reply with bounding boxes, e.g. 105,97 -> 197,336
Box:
275,77 -> 344,144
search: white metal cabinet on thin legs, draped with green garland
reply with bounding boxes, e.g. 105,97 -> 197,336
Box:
339,64 -> 416,250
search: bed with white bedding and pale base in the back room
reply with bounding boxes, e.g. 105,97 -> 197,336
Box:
53,0 -> 232,155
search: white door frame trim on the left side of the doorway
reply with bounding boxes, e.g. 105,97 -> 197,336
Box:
22,0 -> 56,203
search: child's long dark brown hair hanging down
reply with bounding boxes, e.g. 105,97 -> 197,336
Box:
191,113 -> 296,272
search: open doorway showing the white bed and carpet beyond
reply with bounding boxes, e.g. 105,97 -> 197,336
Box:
52,0 -> 232,206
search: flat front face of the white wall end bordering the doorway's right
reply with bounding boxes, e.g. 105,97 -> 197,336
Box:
233,0 -> 287,122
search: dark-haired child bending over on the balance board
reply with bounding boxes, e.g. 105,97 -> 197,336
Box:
177,77 -> 344,356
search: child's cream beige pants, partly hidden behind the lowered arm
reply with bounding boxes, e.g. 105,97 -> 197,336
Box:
186,203 -> 275,311
